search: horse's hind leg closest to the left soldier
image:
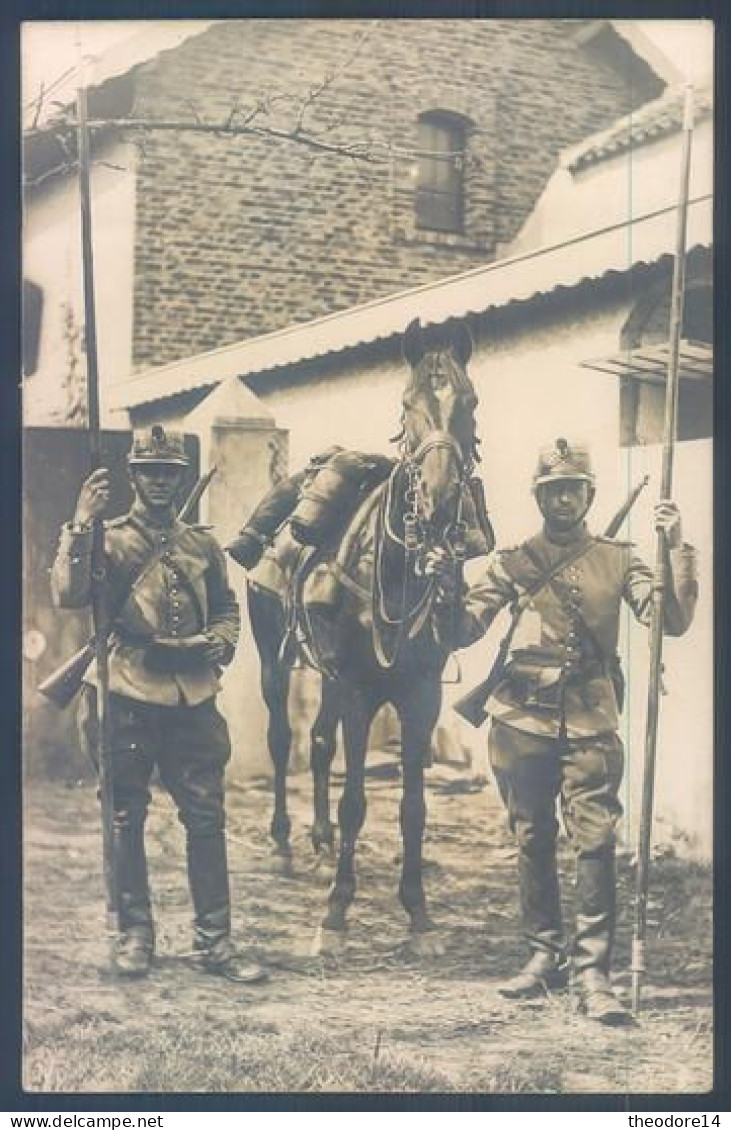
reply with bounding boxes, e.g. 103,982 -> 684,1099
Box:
249,589 -> 291,860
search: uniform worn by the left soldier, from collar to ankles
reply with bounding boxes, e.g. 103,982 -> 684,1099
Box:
51,501 -> 240,954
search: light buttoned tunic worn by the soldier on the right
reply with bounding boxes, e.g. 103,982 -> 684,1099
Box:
456,527 -> 697,739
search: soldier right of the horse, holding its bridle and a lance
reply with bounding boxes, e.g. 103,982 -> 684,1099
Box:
426,440 -> 697,1024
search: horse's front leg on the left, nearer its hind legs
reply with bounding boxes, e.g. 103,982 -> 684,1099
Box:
319,687 -> 376,951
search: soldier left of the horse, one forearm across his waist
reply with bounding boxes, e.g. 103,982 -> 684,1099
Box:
51,425 -> 264,982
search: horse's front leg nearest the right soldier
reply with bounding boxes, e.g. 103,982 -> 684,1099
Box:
397,678 -> 444,956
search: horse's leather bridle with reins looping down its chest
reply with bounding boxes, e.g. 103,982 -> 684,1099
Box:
372,428 -> 473,670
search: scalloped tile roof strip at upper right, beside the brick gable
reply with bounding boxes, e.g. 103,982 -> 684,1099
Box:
564,85 -> 713,173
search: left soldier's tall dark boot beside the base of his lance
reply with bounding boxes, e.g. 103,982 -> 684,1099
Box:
113,812 -> 155,977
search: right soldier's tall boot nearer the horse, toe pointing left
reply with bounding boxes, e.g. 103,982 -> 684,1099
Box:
498,842 -> 568,999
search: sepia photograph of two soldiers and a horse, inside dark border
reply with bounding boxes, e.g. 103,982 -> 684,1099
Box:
21,17 -> 714,1102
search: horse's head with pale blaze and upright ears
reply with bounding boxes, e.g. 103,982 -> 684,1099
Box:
402,319 -> 478,531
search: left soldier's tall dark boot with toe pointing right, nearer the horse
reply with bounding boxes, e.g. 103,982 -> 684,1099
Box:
188,831 -> 266,982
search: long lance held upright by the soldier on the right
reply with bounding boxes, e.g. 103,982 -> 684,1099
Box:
632,86 -> 693,1015
